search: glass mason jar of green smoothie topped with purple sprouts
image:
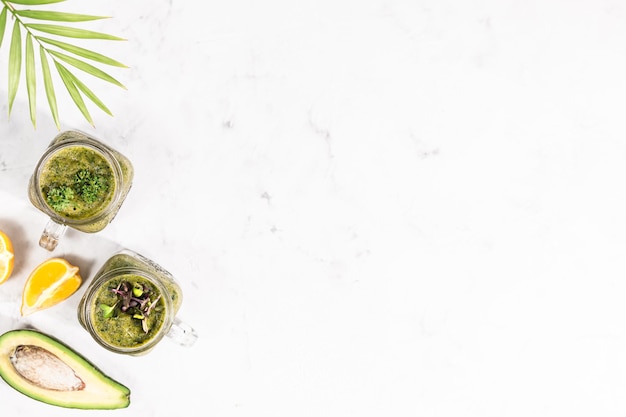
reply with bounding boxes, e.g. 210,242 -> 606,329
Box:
78,249 -> 198,355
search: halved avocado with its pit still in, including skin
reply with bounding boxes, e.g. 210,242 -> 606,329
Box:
0,329 -> 130,410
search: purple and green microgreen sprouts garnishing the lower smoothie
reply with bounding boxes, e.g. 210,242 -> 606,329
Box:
106,281 -> 161,333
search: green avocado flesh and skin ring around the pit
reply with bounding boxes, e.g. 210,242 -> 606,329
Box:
0,329 -> 130,410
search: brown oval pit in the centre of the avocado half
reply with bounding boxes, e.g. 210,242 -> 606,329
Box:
10,345 -> 85,391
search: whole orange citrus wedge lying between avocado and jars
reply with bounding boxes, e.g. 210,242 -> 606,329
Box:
20,258 -> 82,316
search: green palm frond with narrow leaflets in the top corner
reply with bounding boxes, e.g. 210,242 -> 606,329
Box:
0,0 -> 128,129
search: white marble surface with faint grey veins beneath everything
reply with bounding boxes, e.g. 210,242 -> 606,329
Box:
0,0 -> 626,417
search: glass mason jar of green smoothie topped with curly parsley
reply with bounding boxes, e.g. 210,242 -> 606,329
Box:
28,130 -> 134,251
